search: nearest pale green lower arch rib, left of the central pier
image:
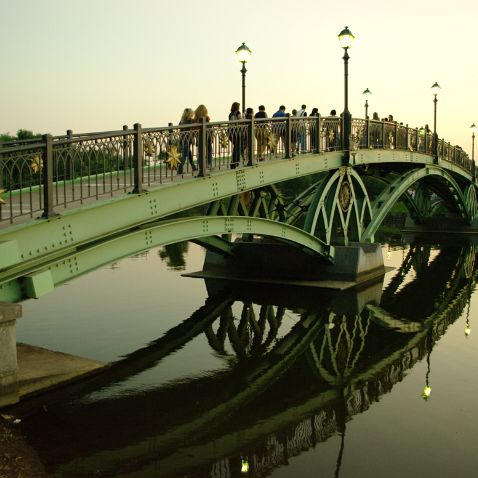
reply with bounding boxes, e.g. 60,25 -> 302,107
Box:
0,216 -> 334,302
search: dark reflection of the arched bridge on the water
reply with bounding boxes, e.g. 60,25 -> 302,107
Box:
12,245 -> 476,476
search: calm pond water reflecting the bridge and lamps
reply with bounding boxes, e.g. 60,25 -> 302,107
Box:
9,240 -> 478,478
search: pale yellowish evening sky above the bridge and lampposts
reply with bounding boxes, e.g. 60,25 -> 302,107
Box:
0,0 -> 478,155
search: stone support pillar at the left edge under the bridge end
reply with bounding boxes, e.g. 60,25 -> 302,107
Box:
0,302 -> 22,407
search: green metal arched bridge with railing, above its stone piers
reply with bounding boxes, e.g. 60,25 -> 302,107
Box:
0,115 -> 478,302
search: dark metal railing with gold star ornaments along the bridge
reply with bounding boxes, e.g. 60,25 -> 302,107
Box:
0,115 -> 474,223
